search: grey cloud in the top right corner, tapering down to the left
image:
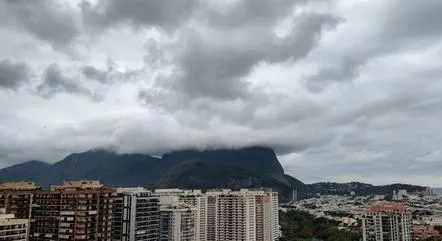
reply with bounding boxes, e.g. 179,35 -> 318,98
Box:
306,0 -> 442,91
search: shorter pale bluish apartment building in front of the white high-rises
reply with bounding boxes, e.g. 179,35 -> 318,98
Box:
159,203 -> 197,241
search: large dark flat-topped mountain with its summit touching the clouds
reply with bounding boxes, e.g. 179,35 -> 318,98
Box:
0,147 -> 304,199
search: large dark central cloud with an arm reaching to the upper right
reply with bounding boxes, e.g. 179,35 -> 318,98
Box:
181,13 -> 338,98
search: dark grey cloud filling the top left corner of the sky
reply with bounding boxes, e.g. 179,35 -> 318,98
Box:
0,0 -> 80,49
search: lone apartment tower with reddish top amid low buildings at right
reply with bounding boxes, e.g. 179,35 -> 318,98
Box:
362,203 -> 412,241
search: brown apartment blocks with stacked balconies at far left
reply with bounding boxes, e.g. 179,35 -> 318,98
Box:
0,180 -> 115,241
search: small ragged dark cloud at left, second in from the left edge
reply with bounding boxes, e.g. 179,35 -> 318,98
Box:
36,64 -> 99,100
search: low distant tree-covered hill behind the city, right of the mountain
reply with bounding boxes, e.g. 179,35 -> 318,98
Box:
305,182 -> 427,196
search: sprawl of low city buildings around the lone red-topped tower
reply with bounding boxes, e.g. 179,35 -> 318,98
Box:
290,192 -> 442,241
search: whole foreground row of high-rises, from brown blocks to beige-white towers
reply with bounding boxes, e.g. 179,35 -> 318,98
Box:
0,180 -> 280,241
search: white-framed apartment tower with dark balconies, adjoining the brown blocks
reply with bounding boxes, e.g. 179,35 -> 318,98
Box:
112,187 -> 160,241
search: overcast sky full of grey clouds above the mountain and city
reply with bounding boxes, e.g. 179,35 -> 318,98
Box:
0,0 -> 442,186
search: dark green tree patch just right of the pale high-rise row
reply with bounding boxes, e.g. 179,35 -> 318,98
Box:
279,210 -> 361,241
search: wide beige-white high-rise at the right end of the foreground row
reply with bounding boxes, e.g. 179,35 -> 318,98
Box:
207,189 -> 280,241
